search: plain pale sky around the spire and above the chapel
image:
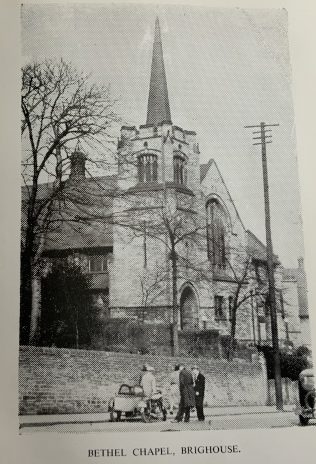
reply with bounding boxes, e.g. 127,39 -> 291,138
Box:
21,4 -> 304,267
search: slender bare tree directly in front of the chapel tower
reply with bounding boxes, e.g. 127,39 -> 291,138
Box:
112,191 -> 206,356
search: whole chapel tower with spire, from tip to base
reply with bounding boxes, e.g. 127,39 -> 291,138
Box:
110,18 -> 200,322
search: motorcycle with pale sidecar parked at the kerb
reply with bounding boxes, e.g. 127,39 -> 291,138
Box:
109,384 -> 167,422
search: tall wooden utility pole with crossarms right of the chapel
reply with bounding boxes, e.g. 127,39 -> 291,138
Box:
245,122 -> 283,411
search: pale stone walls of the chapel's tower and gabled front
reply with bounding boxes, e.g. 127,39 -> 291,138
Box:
110,120 -> 286,348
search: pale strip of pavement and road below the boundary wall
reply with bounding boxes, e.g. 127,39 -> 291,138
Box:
19,405 -> 313,434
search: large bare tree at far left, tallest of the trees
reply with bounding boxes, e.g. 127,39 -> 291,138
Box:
20,60 -> 118,343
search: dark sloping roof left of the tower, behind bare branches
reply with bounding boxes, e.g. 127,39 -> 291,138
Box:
22,176 -> 117,253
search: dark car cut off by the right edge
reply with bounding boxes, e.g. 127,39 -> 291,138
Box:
298,369 -> 316,425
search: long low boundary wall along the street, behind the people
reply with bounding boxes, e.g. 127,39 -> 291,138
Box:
19,346 -> 268,415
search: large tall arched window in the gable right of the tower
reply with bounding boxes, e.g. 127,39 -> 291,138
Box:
206,199 -> 227,268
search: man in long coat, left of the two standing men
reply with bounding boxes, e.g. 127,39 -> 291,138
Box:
174,366 -> 195,422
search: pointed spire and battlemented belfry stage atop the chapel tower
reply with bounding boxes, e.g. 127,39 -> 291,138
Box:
119,17 -> 200,193
